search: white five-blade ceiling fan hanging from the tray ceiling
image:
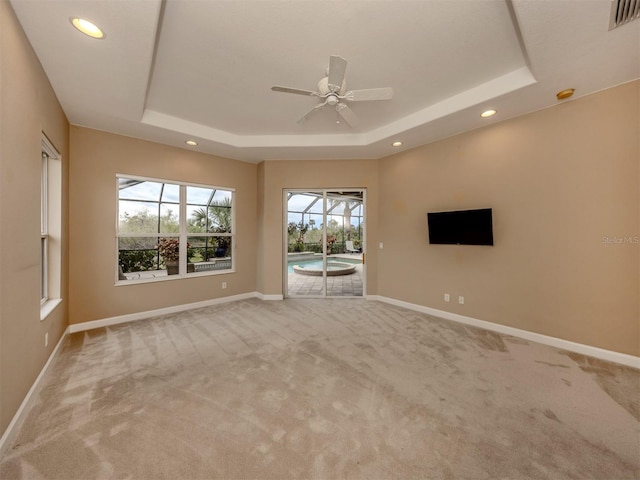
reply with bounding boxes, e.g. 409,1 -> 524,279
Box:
271,55 -> 393,127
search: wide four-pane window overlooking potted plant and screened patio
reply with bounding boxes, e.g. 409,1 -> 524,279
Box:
117,176 -> 235,282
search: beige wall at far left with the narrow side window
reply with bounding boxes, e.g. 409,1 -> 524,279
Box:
0,0 -> 69,435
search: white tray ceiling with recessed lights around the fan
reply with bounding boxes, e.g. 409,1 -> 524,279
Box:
11,0 -> 640,162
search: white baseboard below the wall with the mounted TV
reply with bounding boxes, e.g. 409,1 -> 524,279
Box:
367,295 -> 640,368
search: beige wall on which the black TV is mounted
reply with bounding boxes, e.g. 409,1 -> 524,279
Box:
378,82 -> 640,355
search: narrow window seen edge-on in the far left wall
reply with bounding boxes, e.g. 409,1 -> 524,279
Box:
40,134 -> 62,320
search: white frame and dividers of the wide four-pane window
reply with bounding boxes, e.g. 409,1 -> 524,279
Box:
114,173 -> 236,286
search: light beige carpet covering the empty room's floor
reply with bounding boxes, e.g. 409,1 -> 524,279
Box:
0,299 -> 640,480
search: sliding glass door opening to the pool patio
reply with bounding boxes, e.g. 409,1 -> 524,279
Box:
284,189 -> 365,298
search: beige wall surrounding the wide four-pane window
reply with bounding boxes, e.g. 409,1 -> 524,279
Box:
69,126 -> 257,324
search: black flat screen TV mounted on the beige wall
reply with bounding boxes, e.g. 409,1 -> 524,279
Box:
427,208 -> 493,245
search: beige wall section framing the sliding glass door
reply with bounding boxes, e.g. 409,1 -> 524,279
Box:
258,160 -> 379,295
